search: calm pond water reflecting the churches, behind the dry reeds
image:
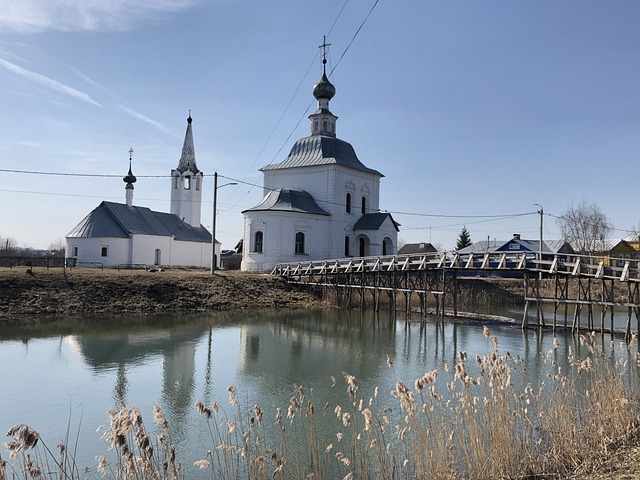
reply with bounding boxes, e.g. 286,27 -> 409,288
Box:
0,311 -> 637,478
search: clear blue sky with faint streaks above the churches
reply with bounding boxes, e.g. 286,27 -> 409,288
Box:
0,0 -> 640,253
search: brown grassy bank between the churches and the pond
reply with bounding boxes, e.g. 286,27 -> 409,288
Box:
0,268 -> 326,323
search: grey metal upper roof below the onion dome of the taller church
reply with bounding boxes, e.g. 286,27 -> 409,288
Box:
260,135 -> 384,177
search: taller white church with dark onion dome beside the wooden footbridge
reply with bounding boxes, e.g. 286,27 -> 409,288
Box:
241,56 -> 398,272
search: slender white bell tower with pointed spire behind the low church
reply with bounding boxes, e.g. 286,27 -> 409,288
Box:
171,110 -> 203,227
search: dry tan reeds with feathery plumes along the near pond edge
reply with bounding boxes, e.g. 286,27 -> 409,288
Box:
0,328 -> 640,480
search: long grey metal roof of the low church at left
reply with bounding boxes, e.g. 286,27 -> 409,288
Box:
67,202 -> 211,243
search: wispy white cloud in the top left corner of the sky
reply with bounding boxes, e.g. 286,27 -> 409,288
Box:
0,0 -> 199,32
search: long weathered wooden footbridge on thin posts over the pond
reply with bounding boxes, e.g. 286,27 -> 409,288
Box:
272,252 -> 640,339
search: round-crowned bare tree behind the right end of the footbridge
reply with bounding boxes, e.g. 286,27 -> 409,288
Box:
557,200 -> 613,253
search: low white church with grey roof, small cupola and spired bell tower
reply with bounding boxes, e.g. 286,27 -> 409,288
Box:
66,114 -> 216,268
